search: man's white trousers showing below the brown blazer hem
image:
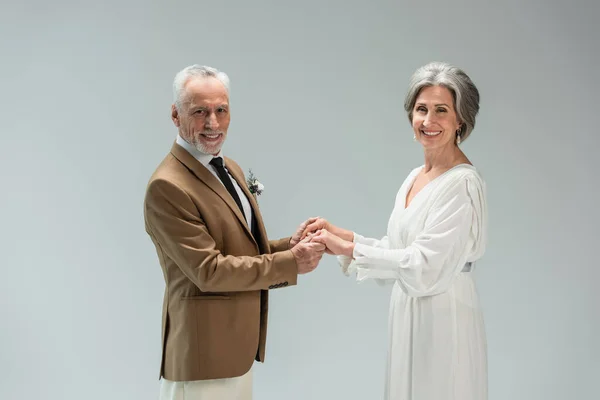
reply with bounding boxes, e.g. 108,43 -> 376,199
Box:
160,368 -> 252,400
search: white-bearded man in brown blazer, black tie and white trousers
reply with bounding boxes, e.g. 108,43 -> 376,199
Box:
144,65 -> 325,400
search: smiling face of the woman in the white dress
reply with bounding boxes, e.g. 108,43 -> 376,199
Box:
412,86 -> 460,150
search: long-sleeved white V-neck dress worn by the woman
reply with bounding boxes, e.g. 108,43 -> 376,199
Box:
338,164 -> 487,400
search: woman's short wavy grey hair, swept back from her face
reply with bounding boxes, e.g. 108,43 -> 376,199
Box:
404,62 -> 479,142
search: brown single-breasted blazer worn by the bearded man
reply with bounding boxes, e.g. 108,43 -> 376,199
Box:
144,143 -> 298,381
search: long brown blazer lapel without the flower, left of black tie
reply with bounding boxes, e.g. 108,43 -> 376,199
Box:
171,143 -> 258,245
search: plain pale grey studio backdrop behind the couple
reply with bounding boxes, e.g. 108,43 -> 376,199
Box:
0,0 -> 600,400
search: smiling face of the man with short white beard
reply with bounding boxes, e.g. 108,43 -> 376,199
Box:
171,77 -> 230,155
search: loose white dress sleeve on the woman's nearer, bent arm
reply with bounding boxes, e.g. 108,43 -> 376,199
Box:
351,181 -> 476,297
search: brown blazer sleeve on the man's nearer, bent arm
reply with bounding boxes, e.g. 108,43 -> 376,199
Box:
144,179 -> 298,292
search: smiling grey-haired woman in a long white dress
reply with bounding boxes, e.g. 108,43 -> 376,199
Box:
305,63 -> 487,400
